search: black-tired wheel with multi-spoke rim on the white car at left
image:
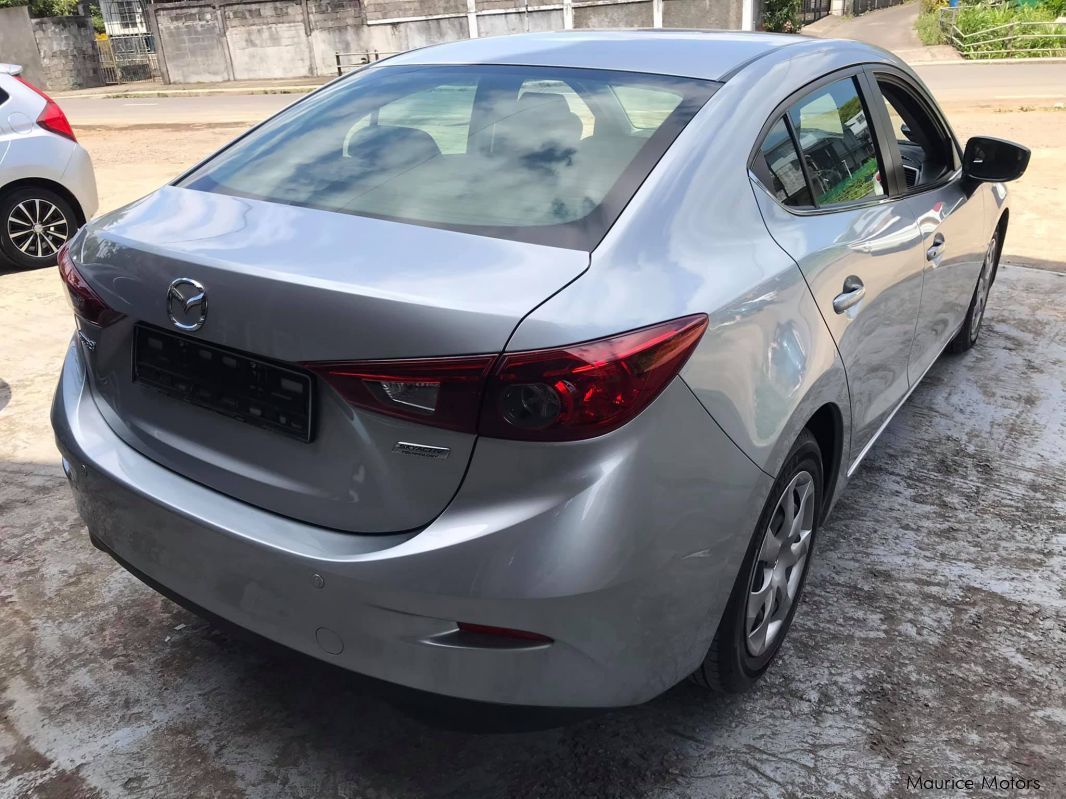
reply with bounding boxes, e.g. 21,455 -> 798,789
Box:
0,186 -> 78,270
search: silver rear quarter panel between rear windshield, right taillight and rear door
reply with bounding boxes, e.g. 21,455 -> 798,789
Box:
508,40 -> 872,507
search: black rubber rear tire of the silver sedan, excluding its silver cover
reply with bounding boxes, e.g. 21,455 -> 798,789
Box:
692,430 -> 823,694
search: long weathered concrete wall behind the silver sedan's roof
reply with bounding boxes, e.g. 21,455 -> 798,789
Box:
150,0 -> 743,83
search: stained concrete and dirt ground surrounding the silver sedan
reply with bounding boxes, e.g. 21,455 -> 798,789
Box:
0,103 -> 1066,799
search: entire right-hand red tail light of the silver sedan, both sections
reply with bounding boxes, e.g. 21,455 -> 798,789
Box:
304,314 -> 707,441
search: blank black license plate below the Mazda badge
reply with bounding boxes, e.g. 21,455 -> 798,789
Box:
133,325 -> 312,441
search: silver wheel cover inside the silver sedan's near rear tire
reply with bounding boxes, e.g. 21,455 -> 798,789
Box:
744,471 -> 815,657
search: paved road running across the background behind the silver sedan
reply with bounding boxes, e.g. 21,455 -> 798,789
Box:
61,63 -> 1066,127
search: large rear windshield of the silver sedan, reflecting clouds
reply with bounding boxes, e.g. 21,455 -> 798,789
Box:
178,65 -> 717,249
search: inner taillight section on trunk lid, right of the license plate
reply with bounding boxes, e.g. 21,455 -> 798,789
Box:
304,355 -> 496,433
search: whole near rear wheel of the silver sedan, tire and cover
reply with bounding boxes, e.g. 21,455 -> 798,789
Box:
692,430 -> 822,694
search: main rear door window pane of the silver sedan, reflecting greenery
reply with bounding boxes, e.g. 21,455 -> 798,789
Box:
789,78 -> 883,206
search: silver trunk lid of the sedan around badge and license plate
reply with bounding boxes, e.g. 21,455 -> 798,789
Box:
75,186 -> 588,533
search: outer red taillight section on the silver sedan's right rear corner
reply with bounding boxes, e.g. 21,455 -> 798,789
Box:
479,313 -> 707,441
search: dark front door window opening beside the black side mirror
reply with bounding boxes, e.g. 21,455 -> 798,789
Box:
877,80 -> 955,189
